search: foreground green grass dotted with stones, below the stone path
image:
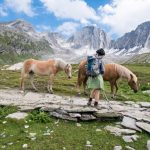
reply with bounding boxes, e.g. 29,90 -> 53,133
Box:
0,107 -> 149,150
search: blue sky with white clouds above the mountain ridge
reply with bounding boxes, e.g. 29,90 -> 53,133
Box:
0,0 -> 150,39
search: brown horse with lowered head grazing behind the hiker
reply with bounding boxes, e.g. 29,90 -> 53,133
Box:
76,60 -> 139,98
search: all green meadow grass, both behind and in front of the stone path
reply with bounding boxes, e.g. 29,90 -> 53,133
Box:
0,65 -> 150,150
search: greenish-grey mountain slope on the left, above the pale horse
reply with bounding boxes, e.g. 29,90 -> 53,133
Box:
0,20 -> 52,55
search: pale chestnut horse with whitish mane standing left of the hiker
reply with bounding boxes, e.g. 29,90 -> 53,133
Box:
20,59 -> 72,93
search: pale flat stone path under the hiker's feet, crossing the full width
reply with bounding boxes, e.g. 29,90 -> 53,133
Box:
0,89 -> 150,122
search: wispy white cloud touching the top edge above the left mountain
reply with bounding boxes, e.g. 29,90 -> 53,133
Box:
4,0 -> 35,17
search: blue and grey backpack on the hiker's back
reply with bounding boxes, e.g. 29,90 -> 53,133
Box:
86,56 -> 100,77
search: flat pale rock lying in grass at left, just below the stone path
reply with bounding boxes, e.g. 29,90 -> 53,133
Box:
6,112 -> 28,120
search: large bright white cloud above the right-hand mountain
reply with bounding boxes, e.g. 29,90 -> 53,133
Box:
98,0 -> 150,36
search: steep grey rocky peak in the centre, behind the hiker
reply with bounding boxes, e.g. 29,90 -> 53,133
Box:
67,26 -> 110,50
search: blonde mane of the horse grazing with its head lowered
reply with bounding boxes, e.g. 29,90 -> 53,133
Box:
114,63 -> 137,82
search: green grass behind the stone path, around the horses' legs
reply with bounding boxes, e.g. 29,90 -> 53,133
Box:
0,64 -> 150,101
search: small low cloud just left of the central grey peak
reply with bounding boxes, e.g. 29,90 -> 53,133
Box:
56,22 -> 80,36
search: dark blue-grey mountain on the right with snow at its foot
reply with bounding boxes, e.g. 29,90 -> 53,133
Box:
111,21 -> 150,54
